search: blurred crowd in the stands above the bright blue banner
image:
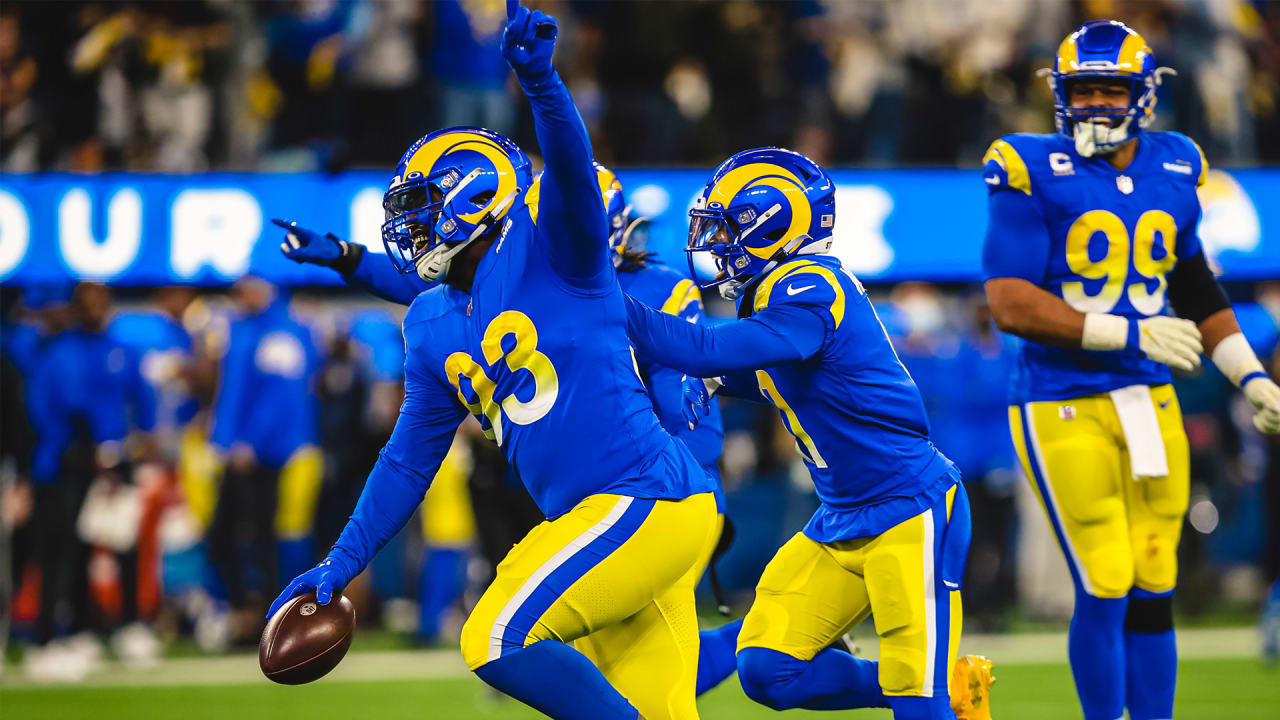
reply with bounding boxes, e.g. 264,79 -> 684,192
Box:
0,0 -> 1280,172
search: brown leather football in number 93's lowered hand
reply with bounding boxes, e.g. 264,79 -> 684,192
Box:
257,591 -> 356,685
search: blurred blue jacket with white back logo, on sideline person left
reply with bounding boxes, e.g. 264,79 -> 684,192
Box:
211,297 -> 320,468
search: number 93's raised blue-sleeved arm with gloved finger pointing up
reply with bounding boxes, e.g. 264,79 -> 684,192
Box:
502,0 -> 613,290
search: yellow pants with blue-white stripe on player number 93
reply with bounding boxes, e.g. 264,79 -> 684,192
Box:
462,493 -> 718,720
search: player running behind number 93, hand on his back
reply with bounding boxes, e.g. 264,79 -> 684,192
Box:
627,147 -> 991,719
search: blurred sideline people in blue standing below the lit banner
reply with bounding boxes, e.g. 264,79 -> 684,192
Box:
0,271 -> 1280,680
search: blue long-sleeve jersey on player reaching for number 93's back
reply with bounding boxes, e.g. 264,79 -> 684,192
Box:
627,256 -> 959,542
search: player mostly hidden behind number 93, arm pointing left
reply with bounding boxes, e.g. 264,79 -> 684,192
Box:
273,163 -> 741,696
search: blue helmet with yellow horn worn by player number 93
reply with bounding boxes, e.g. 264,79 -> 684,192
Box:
383,127 -> 532,282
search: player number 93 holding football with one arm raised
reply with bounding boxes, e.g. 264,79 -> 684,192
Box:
273,0 -> 716,720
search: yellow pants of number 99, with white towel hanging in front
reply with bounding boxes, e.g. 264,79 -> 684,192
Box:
1009,384 -> 1190,598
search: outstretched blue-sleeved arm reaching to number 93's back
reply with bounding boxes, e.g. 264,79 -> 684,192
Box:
627,296 -> 827,378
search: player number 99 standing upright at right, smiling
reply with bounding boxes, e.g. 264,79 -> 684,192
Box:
983,20 -> 1280,720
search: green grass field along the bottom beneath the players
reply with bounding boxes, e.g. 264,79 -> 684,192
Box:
0,660 -> 1280,720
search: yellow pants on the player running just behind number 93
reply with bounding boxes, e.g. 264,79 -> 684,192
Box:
737,488 -> 961,697
